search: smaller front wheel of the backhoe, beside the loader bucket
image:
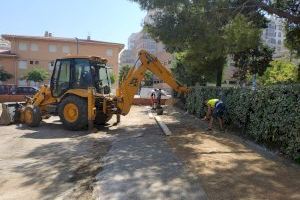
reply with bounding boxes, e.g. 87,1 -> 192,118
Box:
23,105 -> 42,127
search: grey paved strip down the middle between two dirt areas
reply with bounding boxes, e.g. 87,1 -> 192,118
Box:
94,107 -> 206,200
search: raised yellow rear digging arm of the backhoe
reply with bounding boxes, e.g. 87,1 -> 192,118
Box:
117,50 -> 188,115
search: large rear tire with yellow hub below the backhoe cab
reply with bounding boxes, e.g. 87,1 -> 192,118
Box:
58,95 -> 88,131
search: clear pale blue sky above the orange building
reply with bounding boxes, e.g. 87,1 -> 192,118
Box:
0,0 -> 146,45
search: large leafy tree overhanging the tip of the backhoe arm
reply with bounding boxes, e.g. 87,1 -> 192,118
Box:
132,0 -> 265,86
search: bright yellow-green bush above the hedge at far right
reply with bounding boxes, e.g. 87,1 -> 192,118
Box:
260,60 -> 298,85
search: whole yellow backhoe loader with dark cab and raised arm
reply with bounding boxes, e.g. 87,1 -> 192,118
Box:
1,50 -> 188,130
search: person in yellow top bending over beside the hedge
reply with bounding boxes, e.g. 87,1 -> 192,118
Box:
202,99 -> 225,131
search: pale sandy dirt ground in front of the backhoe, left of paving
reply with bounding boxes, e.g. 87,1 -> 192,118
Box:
0,117 -> 111,200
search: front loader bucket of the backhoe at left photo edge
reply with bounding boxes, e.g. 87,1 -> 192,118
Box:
0,102 -> 22,125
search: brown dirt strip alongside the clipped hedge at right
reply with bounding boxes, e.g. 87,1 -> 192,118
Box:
162,107 -> 300,200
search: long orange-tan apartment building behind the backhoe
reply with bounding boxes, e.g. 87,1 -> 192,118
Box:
0,32 -> 124,85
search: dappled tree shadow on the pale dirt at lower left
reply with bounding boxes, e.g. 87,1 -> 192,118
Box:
14,135 -> 110,199
